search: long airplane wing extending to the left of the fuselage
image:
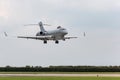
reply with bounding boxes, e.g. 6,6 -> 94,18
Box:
17,36 -> 53,40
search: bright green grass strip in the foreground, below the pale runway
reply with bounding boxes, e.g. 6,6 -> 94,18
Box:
0,77 -> 120,80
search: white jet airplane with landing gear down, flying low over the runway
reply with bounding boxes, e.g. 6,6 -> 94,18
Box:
4,22 -> 77,44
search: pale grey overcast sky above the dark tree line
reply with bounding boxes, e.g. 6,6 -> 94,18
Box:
0,0 -> 120,66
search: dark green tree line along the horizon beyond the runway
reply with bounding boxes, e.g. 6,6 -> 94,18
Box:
0,66 -> 120,72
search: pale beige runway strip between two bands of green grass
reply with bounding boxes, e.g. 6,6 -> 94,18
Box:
0,74 -> 120,77
